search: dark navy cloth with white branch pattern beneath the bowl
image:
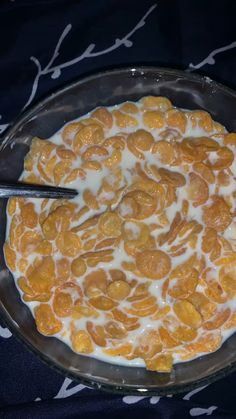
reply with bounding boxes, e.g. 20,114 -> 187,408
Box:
0,0 -> 236,419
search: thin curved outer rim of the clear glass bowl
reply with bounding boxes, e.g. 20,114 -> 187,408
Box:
0,64 -> 236,397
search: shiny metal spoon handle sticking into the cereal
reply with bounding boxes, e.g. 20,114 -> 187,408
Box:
0,182 -> 78,199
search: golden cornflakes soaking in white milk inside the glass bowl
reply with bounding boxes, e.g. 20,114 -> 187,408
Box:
4,96 -> 236,373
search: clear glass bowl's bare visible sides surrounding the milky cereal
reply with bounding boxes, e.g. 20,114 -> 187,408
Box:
0,67 -> 236,395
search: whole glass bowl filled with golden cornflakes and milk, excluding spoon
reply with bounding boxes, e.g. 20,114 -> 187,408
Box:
0,67 -> 236,395
